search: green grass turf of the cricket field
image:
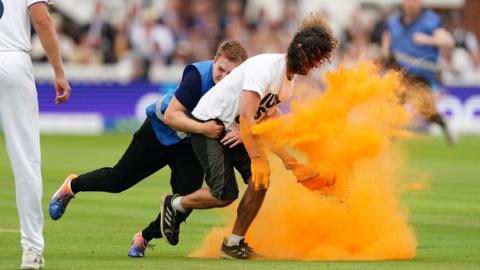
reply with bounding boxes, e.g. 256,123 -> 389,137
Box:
0,134 -> 480,270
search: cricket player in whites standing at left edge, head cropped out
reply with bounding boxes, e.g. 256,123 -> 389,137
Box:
0,0 -> 70,269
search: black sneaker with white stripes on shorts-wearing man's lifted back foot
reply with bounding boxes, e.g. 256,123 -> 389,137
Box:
160,194 -> 180,246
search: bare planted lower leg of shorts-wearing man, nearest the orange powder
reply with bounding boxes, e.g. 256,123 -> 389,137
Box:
232,179 -> 267,236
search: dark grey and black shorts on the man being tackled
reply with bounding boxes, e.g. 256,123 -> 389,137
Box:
192,134 -> 252,201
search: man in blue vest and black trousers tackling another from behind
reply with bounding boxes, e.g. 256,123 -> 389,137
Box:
49,40 -> 248,257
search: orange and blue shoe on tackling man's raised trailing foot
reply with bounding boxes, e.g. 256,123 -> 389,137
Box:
48,174 -> 77,220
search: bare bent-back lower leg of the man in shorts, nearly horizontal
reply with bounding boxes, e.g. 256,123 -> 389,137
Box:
180,188 -> 234,210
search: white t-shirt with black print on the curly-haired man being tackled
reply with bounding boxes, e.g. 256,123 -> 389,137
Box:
192,54 -> 293,130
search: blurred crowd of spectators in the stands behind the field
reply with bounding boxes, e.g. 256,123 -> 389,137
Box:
32,0 -> 480,85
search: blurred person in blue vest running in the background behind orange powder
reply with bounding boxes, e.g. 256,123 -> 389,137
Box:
382,0 -> 454,143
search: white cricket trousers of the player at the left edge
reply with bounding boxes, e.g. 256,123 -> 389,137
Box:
0,51 -> 44,254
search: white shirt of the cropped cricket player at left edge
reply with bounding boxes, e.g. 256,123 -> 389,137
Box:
0,0 -> 48,52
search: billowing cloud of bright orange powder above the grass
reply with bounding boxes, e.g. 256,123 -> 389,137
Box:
192,63 -> 416,260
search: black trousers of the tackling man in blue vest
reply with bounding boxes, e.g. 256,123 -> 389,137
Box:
71,118 -> 204,241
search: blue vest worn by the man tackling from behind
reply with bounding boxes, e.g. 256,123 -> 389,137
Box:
146,60 -> 215,145
